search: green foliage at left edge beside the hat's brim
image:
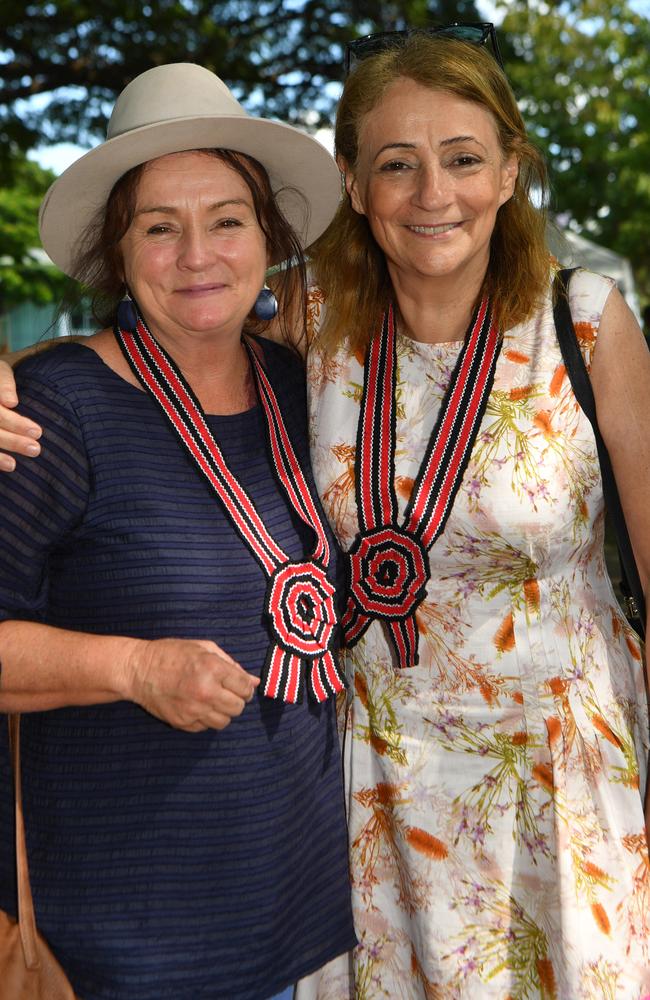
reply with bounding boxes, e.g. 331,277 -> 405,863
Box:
0,157 -> 66,313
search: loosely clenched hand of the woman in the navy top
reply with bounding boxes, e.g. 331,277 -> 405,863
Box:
125,639 -> 259,733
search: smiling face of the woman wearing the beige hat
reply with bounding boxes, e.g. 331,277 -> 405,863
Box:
120,152 -> 267,341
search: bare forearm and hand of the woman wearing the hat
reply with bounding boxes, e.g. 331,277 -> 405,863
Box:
0,621 -> 259,732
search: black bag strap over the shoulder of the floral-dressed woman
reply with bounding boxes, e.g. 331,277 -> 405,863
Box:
553,268 -> 646,639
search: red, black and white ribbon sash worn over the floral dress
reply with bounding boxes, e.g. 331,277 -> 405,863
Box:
343,299 -> 501,667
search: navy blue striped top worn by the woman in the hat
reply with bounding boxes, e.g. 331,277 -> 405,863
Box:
0,341 -> 354,1000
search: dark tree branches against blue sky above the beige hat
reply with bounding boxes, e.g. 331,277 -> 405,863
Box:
0,0 -> 480,149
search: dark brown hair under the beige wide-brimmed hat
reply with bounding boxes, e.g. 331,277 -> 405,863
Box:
69,149 -> 306,347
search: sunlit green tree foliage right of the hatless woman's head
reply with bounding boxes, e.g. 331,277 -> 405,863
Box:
502,0 -> 650,300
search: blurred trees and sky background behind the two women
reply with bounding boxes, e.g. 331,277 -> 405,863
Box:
0,0 -> 650,352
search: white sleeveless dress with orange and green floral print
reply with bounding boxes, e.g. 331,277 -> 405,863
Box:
301,271 -> 650,1000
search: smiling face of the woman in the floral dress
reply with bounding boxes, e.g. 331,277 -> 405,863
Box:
346,78 -> 517,290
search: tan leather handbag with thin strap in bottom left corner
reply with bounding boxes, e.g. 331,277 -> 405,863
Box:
0,715 -> 75,1000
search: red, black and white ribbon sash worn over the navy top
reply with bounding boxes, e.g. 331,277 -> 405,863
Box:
115,317 -> 345,702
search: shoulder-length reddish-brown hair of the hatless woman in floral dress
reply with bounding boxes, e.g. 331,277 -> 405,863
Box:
311,34 -> 549,351
